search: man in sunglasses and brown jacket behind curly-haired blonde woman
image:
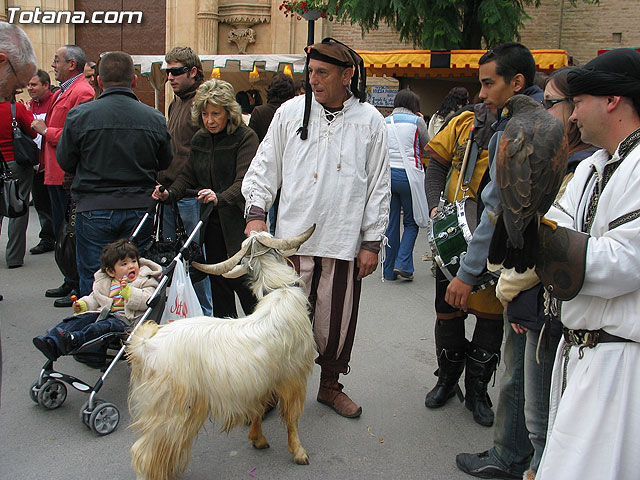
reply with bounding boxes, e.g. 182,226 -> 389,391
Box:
158,47 -> 213,315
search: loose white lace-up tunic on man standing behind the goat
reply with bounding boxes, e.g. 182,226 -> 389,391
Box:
242,95 -> 390,261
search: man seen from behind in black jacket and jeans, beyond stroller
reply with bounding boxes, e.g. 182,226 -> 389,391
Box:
57,52 -> 173,295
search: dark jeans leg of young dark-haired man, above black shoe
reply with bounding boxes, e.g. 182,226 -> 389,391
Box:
489,321 -> 535,471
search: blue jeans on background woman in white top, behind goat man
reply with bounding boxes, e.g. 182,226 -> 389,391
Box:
384,168 -> 418,280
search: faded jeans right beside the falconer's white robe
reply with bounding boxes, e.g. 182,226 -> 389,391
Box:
524,330 -> 560,473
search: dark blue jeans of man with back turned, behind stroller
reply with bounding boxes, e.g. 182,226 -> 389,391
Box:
76,208 -> 153,297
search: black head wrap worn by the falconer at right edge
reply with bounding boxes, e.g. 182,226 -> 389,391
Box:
567,48 -> 640,105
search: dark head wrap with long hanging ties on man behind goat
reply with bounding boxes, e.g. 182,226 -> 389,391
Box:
298,37 -> 367,140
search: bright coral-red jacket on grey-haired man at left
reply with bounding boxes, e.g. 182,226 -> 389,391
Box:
44,75 -> 95,185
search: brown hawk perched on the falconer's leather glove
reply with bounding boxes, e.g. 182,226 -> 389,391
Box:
488,95 -> 568,273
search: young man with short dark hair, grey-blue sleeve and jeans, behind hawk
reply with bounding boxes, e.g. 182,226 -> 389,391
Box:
445,42 -> 543,479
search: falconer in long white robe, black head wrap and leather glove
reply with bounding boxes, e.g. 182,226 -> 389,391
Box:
537,48 -> 640,480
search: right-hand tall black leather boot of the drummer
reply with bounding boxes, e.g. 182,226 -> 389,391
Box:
464,343 -> 500,427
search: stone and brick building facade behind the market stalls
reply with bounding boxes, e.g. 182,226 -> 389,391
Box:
0,0 -> 640,113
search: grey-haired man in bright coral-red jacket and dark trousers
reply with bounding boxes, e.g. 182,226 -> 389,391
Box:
31,45 -> 95,307
